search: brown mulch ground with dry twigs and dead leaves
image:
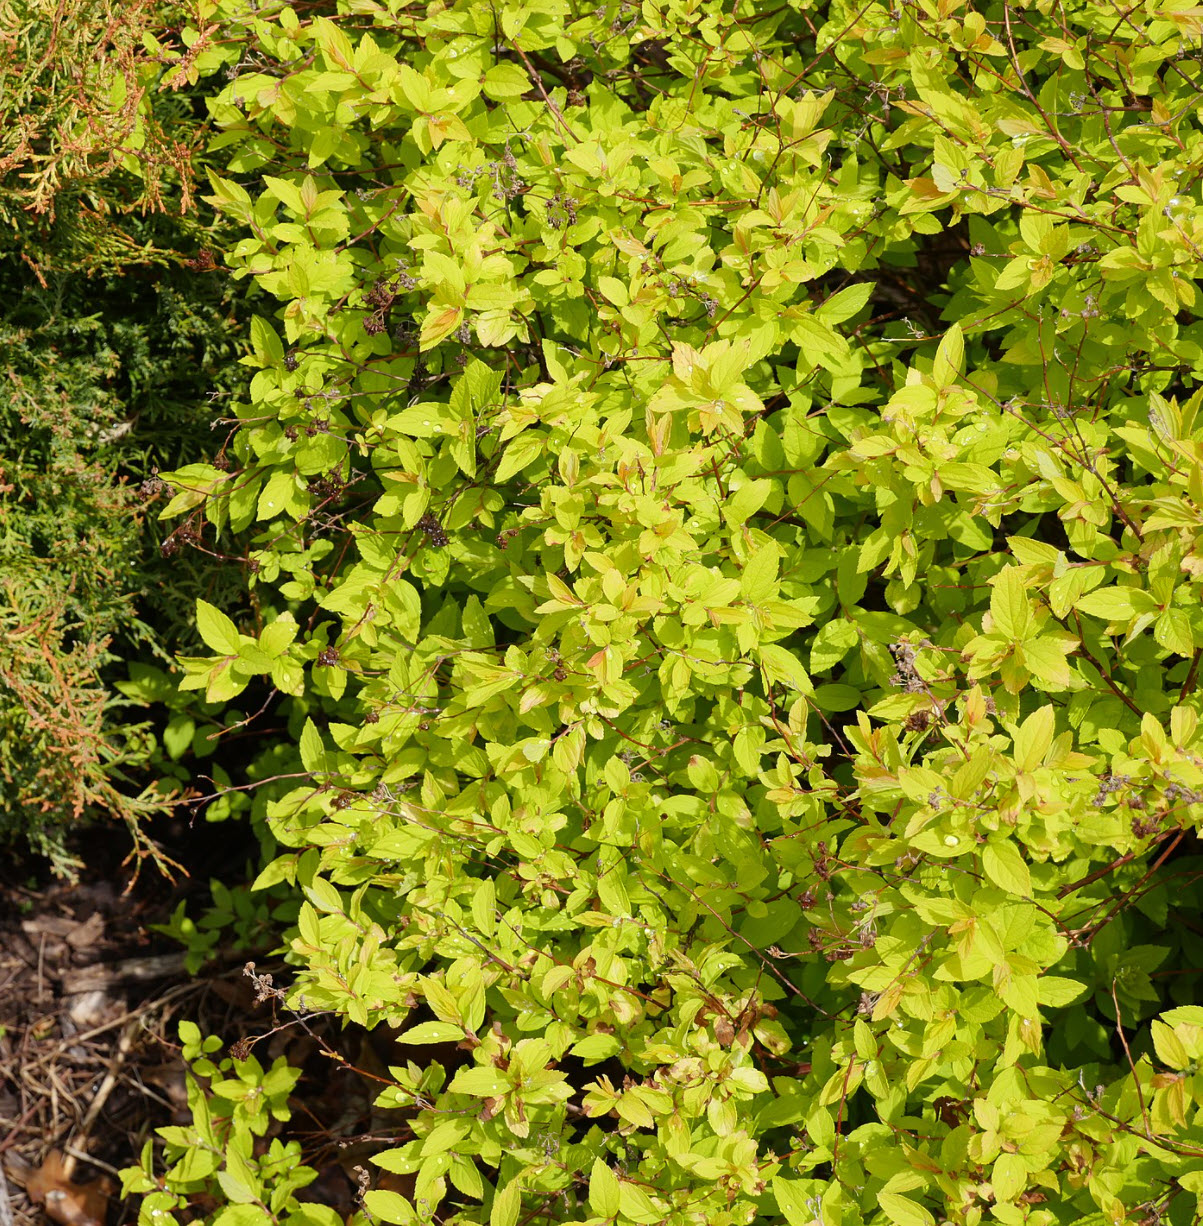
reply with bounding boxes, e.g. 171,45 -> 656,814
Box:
0,824 -> 400,1226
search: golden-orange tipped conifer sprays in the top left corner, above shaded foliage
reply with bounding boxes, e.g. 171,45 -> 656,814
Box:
0,0 -> 201,261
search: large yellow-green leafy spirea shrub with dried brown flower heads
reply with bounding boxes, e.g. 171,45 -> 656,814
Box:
131,0 -> 1203,1226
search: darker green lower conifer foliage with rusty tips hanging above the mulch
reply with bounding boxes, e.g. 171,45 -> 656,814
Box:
0,239 -> 258,868
